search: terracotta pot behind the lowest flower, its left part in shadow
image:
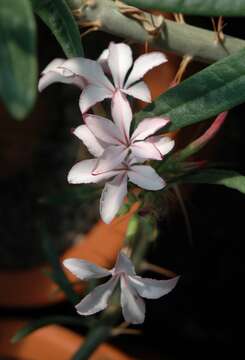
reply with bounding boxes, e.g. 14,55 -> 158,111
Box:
0,212 -> 136,307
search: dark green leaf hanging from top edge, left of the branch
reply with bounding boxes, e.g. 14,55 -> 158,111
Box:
32,0 -> 83,57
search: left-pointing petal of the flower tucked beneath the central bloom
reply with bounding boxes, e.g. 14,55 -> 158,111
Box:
68,159 -> 118,184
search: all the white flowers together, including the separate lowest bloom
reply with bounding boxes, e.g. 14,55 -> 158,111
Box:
39,43 -> 178,324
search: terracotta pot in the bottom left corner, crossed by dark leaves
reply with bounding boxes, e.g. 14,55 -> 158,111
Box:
0,320 -> 133,360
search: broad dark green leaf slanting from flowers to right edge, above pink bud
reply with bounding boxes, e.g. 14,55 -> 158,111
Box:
135,49 -> 245,130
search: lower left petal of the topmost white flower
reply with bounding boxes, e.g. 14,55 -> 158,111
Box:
79,84 -> 112,114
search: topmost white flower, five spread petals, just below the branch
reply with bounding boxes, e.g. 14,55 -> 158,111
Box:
56,42 -> 167,113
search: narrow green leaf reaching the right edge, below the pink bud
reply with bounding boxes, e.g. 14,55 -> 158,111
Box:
181,169 -> 245,194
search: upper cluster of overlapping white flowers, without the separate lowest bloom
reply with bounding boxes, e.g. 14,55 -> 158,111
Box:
39,43 -> 174,223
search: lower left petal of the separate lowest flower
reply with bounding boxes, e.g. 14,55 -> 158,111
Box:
76,277 -> 118,315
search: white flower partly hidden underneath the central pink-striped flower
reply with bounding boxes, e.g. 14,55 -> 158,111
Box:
68,150 -> 166,224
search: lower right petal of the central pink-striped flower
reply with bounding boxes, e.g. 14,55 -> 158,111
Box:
130,141 -> 162,160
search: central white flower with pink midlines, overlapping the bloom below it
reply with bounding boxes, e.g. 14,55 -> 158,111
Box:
84,91 -> 174,175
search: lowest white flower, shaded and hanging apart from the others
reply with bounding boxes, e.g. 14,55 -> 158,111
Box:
63,251 -> 179,324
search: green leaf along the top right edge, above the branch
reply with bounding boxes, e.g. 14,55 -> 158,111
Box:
124,0 -> 245,16
